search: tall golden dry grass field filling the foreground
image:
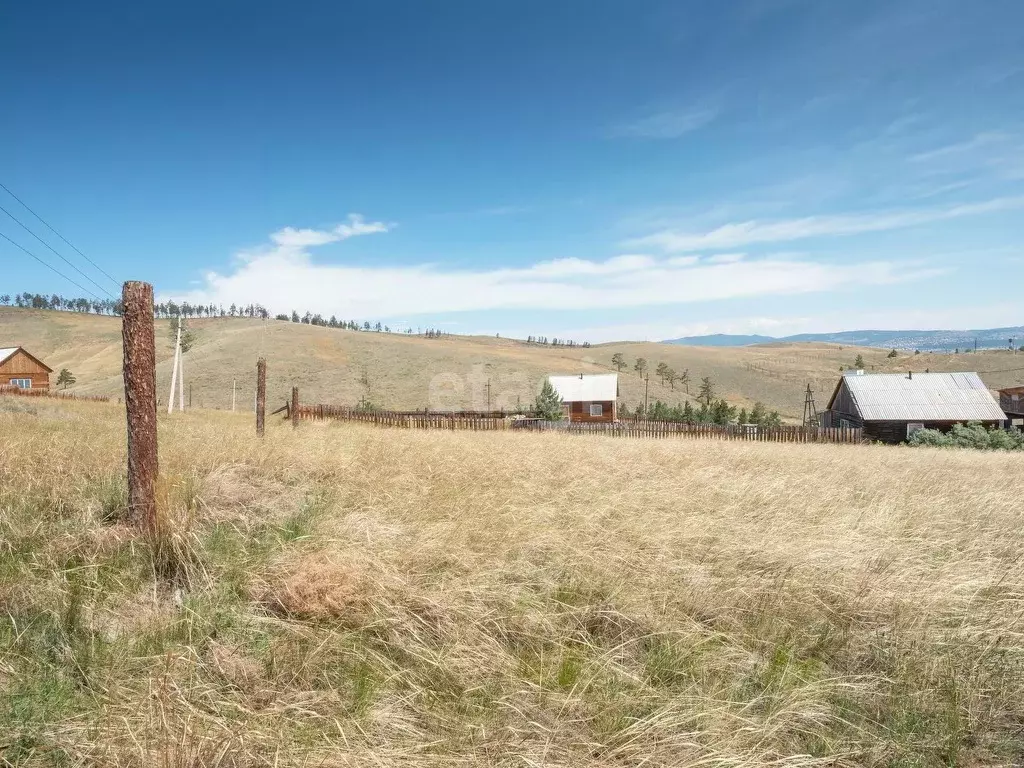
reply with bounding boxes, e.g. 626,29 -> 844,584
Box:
0,393 -> 1024,768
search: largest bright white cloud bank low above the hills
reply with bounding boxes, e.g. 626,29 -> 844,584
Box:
165,217 -> 940,319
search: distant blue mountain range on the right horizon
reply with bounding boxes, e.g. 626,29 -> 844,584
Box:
663,326 -> 1024,352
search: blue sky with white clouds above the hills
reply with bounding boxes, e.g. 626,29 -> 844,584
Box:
0,0 -> 1024,342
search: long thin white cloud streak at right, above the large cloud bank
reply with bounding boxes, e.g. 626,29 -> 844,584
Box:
626,197 -> 1024,253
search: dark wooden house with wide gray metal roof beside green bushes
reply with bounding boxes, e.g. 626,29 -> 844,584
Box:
822,371 -> 1007,443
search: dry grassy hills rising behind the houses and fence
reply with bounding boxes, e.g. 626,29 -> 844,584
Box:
0,307 -> 1024,421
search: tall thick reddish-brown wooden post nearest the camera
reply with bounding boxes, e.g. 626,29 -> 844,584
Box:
121,281 -> 159,531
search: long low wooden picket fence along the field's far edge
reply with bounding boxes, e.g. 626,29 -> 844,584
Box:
297,404 -> 863,443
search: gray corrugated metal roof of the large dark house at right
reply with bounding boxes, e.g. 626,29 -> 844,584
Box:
843,373 -> 1007,421
